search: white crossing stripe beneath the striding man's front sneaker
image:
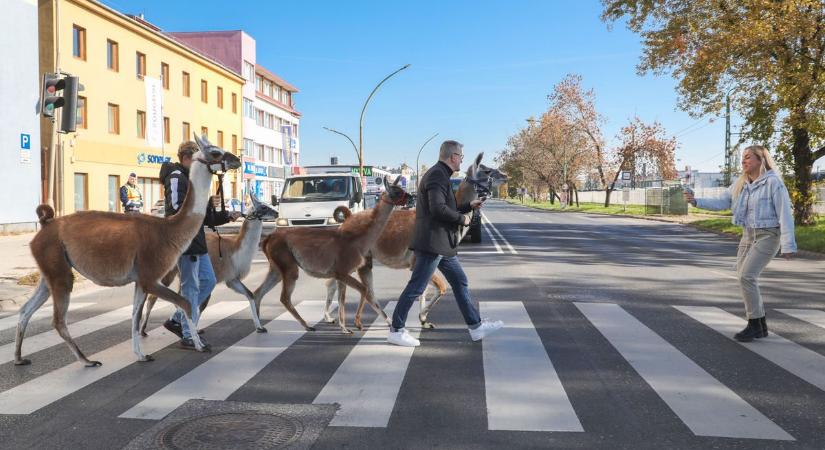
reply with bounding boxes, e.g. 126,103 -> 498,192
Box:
481,302 -> 584,431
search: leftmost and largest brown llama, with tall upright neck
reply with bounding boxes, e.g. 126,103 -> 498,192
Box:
14,136 -> 241,367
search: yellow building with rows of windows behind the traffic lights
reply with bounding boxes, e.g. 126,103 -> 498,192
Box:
39,0 -> 244,214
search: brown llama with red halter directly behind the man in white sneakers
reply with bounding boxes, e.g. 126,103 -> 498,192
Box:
255,177 -> 407,333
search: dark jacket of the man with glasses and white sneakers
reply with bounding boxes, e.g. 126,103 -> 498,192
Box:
412,161 -> 471,256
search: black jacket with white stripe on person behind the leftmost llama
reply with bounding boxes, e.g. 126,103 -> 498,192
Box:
160,163 -> 229,255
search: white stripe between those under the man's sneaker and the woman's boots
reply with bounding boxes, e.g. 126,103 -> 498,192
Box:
575,303 -> 793,440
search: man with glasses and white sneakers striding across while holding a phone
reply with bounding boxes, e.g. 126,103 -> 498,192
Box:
387,141 -> 503,347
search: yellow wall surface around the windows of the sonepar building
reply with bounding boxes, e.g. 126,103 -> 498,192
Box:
50,0 -> 244,214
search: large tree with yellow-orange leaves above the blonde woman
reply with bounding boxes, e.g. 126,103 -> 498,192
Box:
602,0 -> 825,224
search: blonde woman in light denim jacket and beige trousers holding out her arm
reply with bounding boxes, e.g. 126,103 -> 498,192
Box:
684,145 -> 796,342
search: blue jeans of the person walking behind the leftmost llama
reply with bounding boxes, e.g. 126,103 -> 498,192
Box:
172,255 -> 218,339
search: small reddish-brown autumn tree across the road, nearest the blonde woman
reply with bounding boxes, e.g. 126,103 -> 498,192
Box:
604,117 -> 677,208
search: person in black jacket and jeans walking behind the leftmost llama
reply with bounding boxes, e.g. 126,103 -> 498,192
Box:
160,141 -> 240,349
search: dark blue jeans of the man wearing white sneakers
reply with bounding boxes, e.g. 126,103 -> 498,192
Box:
392,251 -> 481,331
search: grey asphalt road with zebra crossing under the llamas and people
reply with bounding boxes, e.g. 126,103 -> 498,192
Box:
0,201 -> 825,449
